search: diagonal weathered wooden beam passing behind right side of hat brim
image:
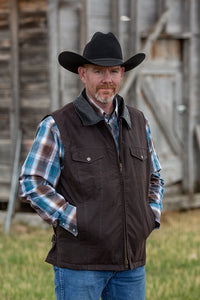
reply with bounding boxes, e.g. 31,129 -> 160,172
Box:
120,9 -> 169,98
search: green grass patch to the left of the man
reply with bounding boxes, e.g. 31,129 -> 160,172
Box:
0,225 -> 55,300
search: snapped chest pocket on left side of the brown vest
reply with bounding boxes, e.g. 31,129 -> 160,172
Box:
72,150 -> 104,201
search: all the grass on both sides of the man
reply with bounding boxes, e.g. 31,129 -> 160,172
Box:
0,210 -> 200,300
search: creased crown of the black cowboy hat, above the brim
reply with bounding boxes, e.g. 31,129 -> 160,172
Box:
83,32 -> 123,62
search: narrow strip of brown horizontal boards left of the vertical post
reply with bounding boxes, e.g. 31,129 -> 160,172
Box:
0,1 -> 11,203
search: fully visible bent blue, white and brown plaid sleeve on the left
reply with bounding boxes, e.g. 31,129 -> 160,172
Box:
19,116 -> 78,236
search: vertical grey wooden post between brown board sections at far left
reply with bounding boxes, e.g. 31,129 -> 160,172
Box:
9,0 -> 20,162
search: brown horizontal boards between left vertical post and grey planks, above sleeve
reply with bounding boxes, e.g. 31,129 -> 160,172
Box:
18,0 -> 50,143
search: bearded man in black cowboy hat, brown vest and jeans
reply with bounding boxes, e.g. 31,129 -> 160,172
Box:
20,32 -> 163,300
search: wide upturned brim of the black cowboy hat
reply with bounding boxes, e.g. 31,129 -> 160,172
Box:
58,51 -> 145,74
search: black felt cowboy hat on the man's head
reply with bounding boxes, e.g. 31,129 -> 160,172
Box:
58,32 -> 145,74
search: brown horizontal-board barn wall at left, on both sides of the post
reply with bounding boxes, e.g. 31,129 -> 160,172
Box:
0,0 -> 50,201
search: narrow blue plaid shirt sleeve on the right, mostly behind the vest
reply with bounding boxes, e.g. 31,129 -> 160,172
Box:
146,119 -> 164,228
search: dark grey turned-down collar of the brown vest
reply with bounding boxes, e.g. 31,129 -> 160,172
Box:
73,89 -> 131,128
